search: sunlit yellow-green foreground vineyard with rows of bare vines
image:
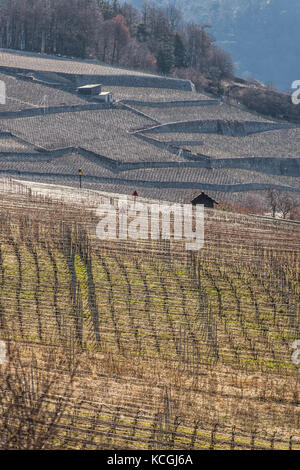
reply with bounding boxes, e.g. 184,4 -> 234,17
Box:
0,180 -> 300,449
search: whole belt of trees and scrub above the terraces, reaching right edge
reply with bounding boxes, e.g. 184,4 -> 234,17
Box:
0,0 -> 300,122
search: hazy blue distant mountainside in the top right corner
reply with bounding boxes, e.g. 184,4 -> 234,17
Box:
131,0 -> 300,90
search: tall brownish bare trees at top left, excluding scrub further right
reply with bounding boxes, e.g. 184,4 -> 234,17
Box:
0,0 -> 233,84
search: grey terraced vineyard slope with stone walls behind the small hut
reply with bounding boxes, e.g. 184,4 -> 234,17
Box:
0,47 -> 300,211
